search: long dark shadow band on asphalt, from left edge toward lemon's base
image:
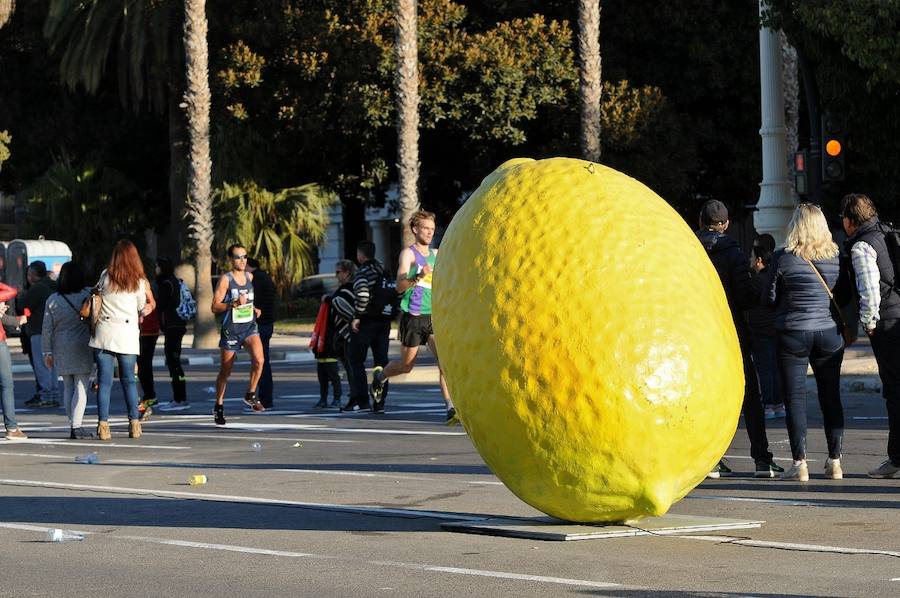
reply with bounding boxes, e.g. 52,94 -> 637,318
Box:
0,496 -> 472,538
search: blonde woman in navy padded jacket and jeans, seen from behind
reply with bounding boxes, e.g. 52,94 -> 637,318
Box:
769,203 -> 848,482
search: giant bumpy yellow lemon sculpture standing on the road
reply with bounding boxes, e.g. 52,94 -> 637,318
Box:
433,158 -> 744,523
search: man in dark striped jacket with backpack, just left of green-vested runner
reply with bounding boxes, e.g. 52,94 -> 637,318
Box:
341,240 -> 397,412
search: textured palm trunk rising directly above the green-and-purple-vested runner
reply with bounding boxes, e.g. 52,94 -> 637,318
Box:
396,0 -> 419,251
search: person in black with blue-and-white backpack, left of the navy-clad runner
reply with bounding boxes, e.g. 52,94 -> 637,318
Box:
156,257 -> 189,413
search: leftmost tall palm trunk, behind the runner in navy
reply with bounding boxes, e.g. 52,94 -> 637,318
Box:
184,0 -> 217,349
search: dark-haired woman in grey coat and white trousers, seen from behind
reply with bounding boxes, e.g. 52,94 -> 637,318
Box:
41,262 -> 94,440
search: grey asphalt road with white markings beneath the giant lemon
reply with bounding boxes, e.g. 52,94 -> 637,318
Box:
0,363 -> 900,598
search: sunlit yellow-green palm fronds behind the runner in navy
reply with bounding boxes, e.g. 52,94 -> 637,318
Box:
213,182 -> 337,295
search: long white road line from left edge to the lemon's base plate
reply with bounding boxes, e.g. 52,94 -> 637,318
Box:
0,479 -> 488,521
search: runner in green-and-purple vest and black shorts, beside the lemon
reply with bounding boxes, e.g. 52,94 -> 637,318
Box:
369,210 -> 459,425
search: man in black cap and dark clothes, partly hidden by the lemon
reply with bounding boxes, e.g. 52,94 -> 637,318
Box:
697,199 -> 784,478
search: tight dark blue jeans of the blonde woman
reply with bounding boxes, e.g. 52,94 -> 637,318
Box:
778,327 -> 844,460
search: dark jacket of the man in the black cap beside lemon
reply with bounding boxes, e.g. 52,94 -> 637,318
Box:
697,229 -> 759,348
